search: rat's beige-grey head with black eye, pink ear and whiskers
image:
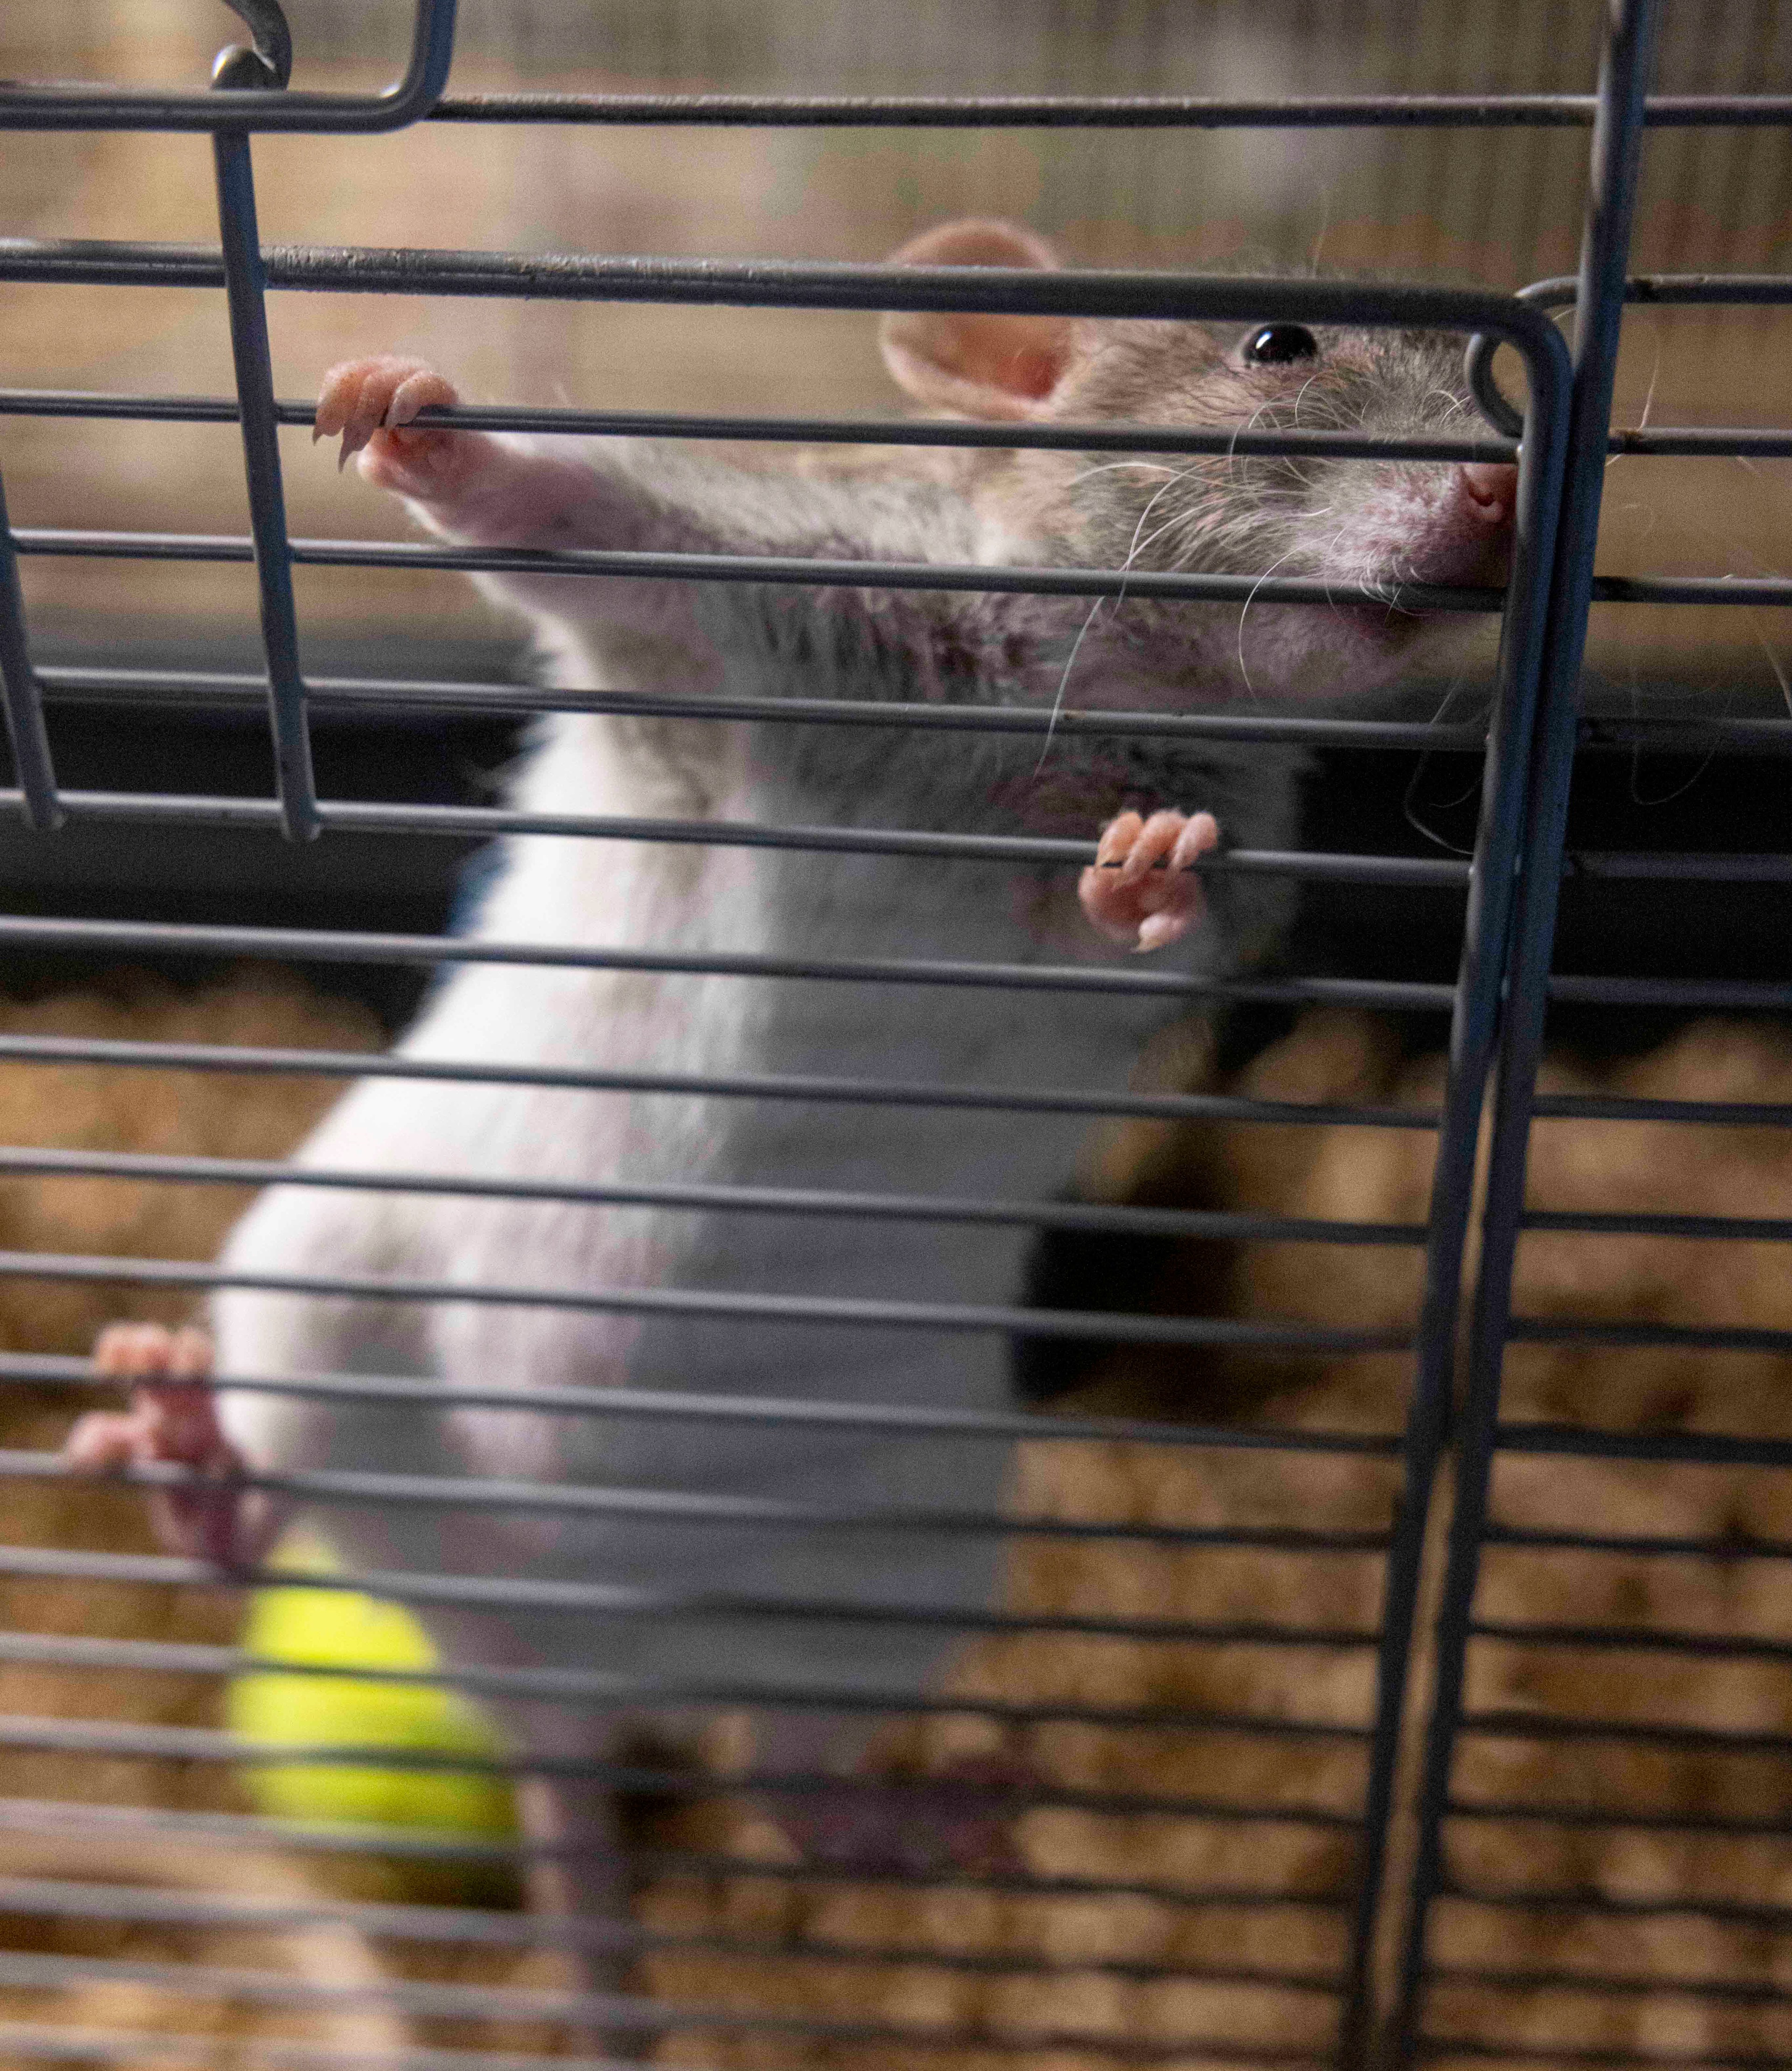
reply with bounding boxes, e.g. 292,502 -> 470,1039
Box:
882,222 -> 1519,696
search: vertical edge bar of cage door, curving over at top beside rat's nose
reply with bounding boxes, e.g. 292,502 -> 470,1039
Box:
1340,334 -> 1570,2065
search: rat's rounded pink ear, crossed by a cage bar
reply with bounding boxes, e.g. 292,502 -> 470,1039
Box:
881,222 -> 1075,418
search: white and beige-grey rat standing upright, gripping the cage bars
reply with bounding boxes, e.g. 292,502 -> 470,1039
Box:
68,222 -> 1517,1938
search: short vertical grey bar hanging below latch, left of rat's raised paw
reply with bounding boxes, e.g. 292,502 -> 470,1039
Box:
211,101 -> 319,841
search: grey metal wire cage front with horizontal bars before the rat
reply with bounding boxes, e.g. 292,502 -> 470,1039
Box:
0,0 -> 1792,2071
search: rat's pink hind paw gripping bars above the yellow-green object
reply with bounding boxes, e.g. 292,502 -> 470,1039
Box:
62,1323 -> 275,1568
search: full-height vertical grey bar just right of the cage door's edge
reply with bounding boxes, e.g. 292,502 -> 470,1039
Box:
1390,0 -> 1657,2065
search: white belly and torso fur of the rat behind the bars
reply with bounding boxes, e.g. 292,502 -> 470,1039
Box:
213,441 -> 1164,1864
